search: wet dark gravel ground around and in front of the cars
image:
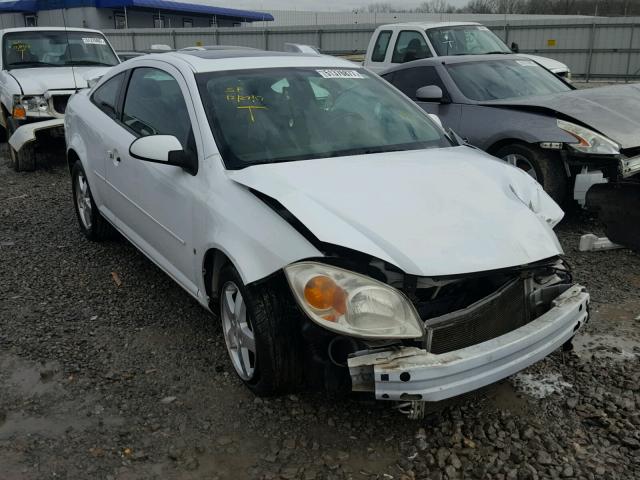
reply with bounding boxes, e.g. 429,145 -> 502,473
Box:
0,151 -> 640,480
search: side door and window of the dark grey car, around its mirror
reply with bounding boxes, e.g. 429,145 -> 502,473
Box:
382,66 -> 461,130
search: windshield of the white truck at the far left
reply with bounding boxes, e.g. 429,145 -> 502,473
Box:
2,30 -> 118,70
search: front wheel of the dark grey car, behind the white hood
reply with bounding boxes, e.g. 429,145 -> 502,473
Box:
495,143 -> 568,204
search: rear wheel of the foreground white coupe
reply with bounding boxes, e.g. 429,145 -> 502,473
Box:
71,161 -> 113,242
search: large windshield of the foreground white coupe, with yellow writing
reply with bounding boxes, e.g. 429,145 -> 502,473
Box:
196,68 -> 451,169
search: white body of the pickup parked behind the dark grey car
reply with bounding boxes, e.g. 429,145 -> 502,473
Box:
364,22 -> 570,74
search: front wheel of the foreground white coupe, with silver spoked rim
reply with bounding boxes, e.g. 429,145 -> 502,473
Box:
219,265 -> 303,396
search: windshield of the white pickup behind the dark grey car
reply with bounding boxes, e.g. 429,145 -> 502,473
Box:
427,25 -> 511,57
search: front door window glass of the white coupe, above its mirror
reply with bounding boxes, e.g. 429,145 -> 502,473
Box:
122,68 -> 192,149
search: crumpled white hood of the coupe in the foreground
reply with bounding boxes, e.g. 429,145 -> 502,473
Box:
229,147 -> 563,276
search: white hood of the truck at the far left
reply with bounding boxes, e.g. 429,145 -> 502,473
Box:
10,66 -> 111,95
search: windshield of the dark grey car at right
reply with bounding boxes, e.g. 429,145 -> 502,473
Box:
447,59 -> 572,100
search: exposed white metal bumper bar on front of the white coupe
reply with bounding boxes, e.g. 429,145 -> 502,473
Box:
348,285 -> 589,401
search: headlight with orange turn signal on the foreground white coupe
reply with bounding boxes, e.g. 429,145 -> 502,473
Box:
284,262 -> 422,338
